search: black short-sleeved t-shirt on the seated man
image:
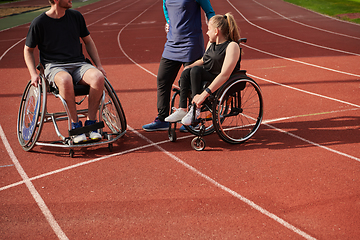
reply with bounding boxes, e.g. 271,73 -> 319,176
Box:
25,9 -> 90,64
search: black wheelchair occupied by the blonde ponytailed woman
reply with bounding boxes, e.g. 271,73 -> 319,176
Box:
168,38 -> 263,151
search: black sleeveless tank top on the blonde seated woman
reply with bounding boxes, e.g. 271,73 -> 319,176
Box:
203,41 -> 240,75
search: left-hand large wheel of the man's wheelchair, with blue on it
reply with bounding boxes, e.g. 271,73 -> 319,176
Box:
17,78 -> 46,151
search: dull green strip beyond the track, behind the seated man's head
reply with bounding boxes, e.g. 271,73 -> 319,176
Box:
0,0 -> 99,31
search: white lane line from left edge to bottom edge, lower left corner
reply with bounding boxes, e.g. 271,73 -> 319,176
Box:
0,125 -> 68,240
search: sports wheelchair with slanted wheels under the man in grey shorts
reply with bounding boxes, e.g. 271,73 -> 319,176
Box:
17,60 -> 127,157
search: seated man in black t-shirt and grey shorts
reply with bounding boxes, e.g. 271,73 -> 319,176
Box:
24,0 -> 106,143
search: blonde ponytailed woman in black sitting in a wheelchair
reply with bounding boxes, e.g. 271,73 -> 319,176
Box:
165,13 -> 241,125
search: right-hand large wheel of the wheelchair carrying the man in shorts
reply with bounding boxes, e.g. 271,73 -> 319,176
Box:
102,78 -> 126,134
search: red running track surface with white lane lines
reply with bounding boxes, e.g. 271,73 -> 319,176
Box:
0,0 -> 360,239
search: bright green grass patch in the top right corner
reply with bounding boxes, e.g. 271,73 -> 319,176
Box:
285,0 -> 360,23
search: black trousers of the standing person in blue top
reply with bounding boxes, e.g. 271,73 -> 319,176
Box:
157,57 -> 192,121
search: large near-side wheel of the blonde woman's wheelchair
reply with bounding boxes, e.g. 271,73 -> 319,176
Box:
213,79 -> 263,144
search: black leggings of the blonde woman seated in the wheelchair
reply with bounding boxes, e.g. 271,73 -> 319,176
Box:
179,66 -> 216,108
